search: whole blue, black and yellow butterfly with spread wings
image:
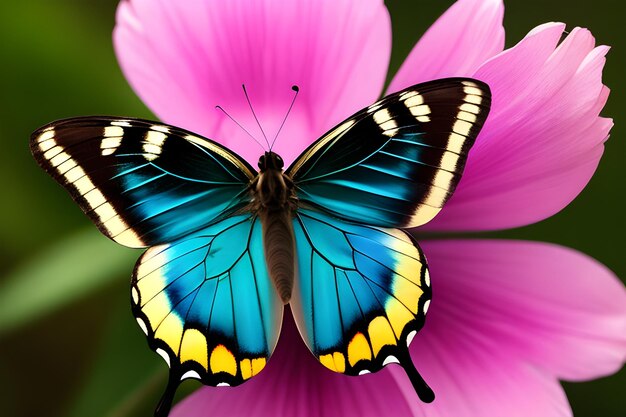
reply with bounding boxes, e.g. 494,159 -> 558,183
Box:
30,78 -> 491,417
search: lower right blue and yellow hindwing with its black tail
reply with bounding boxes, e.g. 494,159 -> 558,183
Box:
291,209 -> 432,401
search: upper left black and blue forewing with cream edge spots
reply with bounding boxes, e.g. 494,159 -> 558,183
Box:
30,117 -> 256,247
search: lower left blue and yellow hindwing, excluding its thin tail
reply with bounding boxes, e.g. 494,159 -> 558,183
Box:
131,215 -> 283,386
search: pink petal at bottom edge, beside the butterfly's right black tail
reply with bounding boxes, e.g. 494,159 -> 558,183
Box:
390,342 -> 572,417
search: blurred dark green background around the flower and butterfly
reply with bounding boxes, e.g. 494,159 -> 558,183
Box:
0,0 -> 626,417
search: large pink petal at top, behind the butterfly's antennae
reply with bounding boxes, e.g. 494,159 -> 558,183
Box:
114,0 -> 391,163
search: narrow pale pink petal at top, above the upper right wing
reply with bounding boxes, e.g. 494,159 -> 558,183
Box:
388,0 -> 504,93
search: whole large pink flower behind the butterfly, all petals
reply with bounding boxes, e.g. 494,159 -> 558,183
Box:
115,0 -> 626,417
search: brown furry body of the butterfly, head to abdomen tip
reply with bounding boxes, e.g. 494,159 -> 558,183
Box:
250,152 -> 297,304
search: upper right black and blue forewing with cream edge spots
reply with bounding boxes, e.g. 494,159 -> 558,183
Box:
286,78 -> 491,227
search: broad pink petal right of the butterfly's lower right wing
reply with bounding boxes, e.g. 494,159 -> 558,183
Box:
411,240 -> 626,384
